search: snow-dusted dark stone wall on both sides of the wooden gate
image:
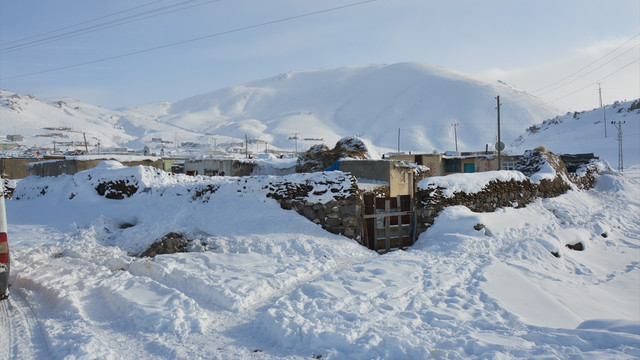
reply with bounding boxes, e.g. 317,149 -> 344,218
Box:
267,151 -> 597,240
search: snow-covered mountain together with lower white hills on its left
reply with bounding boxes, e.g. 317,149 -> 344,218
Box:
0,63 -> 563,152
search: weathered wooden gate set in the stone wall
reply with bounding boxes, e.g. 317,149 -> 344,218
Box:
362,194 -> 416,253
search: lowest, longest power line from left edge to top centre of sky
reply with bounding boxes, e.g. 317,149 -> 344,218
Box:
0,0 -> 377,80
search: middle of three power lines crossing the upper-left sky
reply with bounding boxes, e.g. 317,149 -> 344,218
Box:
1,0 -> 220,53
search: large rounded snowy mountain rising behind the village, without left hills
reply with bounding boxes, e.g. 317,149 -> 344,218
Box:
127,63 -> 559,152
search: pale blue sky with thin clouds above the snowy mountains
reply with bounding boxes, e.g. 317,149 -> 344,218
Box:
0,0 -> 640,110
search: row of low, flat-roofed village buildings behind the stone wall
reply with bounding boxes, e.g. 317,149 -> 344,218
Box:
0,127 -> 594,196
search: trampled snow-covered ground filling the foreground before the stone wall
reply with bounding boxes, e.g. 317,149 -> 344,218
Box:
0,162 -> 640,359
